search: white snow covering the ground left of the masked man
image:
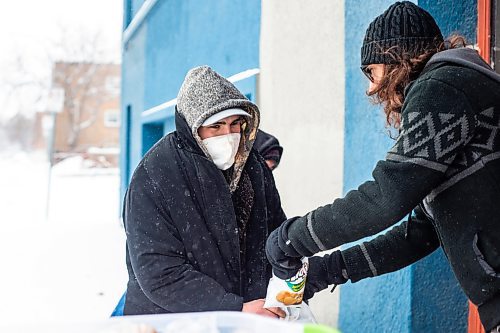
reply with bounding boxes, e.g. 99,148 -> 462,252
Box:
0,153 -> 127,327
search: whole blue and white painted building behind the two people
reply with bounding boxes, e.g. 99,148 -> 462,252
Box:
121,0 -> 500,332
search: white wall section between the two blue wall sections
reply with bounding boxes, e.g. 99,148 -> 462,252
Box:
257,0 -> 344,326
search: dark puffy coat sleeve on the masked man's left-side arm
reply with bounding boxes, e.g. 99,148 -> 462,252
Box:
124,166 -> 243,312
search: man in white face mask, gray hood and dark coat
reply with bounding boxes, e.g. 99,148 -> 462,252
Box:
123,66 -> 286,317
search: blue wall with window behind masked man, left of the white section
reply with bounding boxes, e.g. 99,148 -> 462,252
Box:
121,0 -> 260,197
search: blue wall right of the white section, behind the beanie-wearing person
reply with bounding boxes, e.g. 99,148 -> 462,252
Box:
339,0 -> 477,333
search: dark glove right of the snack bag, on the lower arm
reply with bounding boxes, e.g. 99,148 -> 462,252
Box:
304,251 -> 347,300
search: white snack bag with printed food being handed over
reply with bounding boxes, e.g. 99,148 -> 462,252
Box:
264,258 -> 309,308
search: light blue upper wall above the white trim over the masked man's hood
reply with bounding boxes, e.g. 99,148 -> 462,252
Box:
145,0 -> 260,107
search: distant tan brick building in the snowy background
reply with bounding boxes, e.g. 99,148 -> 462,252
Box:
34,62 -> 121,166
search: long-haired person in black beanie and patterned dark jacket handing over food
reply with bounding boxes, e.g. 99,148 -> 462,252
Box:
266,1 -> 500,332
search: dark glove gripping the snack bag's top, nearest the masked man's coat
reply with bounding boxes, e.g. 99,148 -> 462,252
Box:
266,219 -> 302,280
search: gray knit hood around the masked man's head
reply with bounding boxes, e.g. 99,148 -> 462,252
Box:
177,66 -> 260,192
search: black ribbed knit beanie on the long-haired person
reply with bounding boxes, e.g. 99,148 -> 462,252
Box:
361,1 -> 443,65
